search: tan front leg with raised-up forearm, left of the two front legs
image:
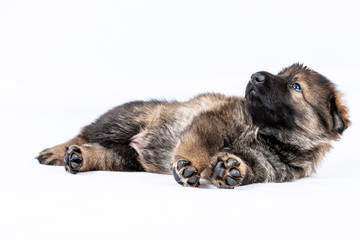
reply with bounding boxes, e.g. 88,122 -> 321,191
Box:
173,112 -> 228,186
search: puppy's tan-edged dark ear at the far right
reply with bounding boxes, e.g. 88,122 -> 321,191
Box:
329,94 -> 351,134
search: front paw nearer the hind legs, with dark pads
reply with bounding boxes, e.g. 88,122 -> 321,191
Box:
172,159 -> 200,187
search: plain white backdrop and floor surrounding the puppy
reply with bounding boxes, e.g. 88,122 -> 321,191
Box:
0,0 -> 360,239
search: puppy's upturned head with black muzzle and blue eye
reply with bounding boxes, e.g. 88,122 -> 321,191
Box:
245,64 -> 350,144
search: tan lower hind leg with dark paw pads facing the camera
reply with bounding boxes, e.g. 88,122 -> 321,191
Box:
64,143 -> 136,173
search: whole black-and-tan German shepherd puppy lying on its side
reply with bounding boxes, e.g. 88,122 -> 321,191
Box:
36,64 -> 350,188
